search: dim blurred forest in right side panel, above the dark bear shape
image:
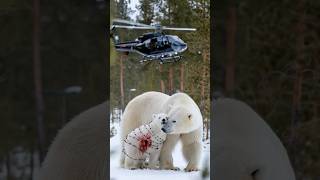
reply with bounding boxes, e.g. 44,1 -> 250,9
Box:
213,0 -> 320,179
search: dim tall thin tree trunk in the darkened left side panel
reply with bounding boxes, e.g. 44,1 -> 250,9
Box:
33,0 -> 46,162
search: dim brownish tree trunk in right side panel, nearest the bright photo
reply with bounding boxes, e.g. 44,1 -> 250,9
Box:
225,6 -> 237,96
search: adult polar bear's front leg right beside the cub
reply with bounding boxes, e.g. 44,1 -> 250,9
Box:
160,134 -> 180,170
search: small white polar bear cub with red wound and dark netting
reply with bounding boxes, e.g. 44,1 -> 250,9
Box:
122,113 -> 171,169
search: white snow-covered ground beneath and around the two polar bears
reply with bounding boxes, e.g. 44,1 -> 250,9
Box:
110,129 -> 210,180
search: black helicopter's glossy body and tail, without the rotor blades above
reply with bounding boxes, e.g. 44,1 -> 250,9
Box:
115,32 -> 187,59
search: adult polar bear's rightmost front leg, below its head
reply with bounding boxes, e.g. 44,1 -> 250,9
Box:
181,128 -> 202,172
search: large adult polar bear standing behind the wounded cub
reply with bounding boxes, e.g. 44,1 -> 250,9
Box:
120,91 -> 203,171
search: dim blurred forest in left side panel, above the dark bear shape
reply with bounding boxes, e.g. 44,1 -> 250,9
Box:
0,0 -> 107,179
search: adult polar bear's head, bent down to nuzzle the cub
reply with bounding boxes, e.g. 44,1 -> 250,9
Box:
163,106 -> 202,134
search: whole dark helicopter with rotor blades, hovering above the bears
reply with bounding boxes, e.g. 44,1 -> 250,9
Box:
110,19 -> 196,64
